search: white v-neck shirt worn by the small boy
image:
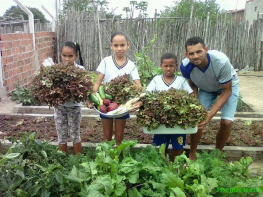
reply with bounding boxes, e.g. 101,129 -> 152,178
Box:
146,75 -> 193,94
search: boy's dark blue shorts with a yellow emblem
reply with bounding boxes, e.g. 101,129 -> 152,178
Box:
153,134 -> 186,150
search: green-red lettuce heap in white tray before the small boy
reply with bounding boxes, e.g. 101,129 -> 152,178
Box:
136,88 -> 206,130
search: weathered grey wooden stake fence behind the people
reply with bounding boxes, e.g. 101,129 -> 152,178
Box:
57,10 -> 263,70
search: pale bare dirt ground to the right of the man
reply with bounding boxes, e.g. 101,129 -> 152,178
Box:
238,71 -> 263,112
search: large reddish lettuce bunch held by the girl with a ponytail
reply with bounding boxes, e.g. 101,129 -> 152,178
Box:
30,64 -> 93,106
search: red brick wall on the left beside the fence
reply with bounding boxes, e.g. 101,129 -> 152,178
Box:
0,32 -> 55,93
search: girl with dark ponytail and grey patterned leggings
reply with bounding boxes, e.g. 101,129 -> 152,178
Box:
54,41 -> 85,154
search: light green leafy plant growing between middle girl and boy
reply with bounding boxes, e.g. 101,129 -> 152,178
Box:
134,34 -> 163,86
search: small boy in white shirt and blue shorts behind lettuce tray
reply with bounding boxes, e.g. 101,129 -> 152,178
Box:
146,53 -> 193,161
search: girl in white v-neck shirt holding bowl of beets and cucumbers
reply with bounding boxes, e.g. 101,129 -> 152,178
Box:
93,32 -> 142,145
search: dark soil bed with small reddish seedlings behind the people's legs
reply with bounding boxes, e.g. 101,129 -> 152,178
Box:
0,115 -> 263,147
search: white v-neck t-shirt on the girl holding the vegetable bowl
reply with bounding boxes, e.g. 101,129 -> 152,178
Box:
96,55 -> 140,83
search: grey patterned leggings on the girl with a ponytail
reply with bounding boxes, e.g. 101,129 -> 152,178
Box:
54,106 -> 82,144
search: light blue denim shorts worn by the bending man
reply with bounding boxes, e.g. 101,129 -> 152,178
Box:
198,84 -> 239,122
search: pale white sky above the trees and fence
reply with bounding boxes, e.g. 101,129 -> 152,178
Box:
0,0 -> 246,21
